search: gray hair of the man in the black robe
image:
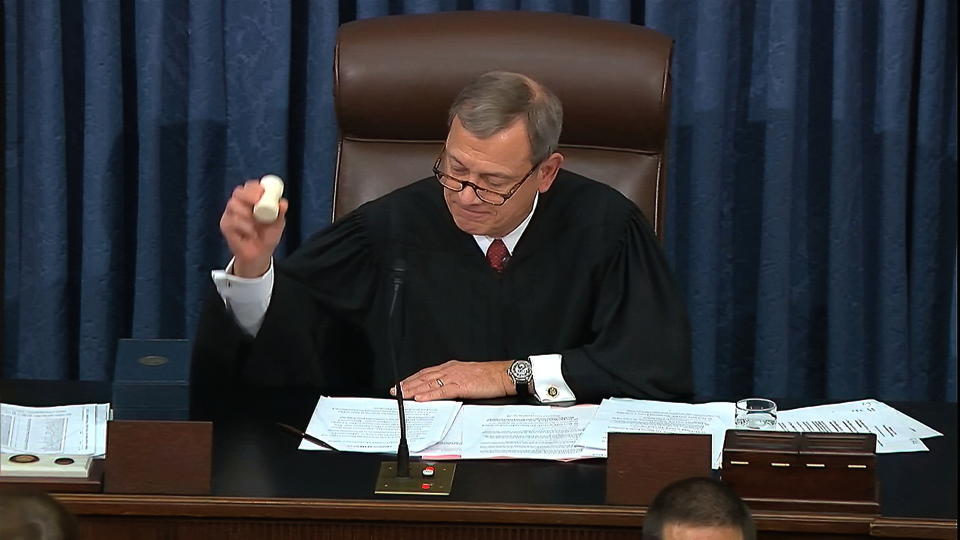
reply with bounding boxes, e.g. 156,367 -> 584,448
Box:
447,71 -> 563,164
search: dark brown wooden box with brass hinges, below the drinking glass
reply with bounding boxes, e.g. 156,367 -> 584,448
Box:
723,430 -> 880,514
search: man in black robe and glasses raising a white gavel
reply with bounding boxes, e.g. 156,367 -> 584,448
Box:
195,72 -> 692,402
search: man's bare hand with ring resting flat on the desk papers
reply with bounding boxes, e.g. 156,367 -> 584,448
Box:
390,360 -> 517,401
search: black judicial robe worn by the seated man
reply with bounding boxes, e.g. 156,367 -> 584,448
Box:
194,170 -> 693,401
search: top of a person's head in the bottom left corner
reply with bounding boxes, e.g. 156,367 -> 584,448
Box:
0,490 -> 78,540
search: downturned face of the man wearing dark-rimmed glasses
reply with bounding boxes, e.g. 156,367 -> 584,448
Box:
439,118 -> 563,238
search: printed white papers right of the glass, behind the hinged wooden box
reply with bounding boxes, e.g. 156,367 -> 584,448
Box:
777,399 -> 941,454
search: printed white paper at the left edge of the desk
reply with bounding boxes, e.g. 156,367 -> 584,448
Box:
0,403 -> 111,457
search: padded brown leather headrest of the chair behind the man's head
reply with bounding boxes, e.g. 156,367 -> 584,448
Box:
334,11 -> 673,153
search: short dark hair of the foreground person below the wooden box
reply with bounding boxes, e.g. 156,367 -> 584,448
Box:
643,477 -> 757,540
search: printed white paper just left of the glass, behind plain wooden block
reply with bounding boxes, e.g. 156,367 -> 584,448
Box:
579,398 -> 734,469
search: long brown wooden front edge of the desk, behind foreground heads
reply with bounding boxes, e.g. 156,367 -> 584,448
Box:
57,493 -> 957,539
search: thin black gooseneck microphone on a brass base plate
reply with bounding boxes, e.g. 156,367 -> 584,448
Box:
374,258 -> 457,495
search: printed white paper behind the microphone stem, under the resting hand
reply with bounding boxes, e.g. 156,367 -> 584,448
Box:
300,397 -> 461,453
